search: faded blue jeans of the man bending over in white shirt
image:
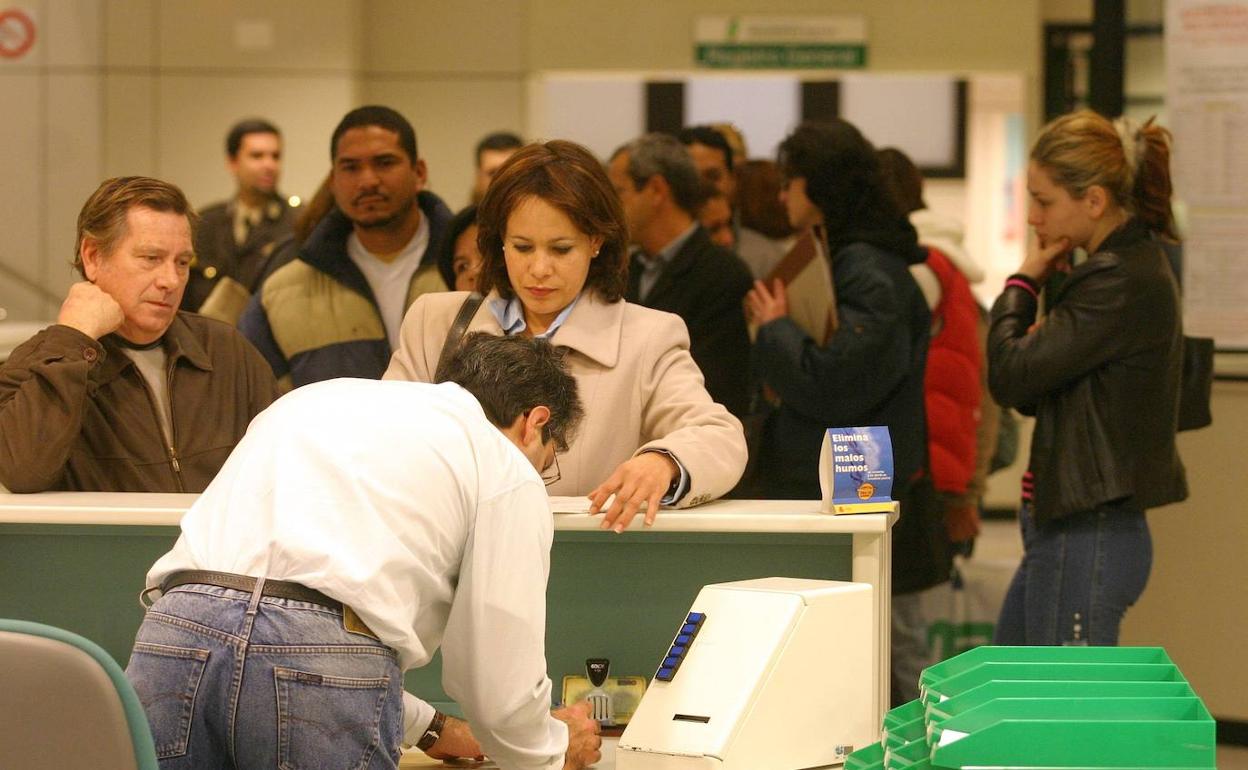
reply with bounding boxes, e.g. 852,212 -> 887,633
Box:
126,584 -> 403,770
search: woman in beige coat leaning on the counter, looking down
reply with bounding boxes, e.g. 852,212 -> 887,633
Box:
386,141 -> 749,532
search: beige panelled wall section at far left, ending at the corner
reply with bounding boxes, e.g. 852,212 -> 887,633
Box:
0,0 -> 362,319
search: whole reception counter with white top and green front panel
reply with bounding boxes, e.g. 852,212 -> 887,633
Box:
0,493 -> 897,719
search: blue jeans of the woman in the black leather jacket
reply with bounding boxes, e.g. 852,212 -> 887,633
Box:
993,504 -> 1153,645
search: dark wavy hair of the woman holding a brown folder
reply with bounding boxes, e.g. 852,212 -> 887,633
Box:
778,119 -> 902,252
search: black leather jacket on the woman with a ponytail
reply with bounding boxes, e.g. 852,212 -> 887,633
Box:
988,220 -> 1187,523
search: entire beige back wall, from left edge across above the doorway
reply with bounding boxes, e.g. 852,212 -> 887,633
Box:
0,0 -> 1042,319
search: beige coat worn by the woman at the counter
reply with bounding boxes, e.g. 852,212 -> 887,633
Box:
384,292 -> 749,508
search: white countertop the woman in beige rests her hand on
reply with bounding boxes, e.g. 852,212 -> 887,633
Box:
0,492 -> 896,533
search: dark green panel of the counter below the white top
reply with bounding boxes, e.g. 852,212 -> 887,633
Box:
0,524 -> 851,704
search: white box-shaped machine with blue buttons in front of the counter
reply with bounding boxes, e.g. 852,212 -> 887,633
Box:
615,578 -> 879,770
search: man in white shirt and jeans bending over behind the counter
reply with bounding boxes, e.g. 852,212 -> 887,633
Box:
126,333 -> 600,770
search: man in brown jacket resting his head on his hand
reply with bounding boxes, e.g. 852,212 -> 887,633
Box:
0,176 -> 277,492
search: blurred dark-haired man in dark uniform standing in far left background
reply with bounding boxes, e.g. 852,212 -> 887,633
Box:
182,119 -> 295,323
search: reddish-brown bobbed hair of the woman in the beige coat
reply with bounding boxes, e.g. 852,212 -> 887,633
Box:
477,140 -> 628,302
